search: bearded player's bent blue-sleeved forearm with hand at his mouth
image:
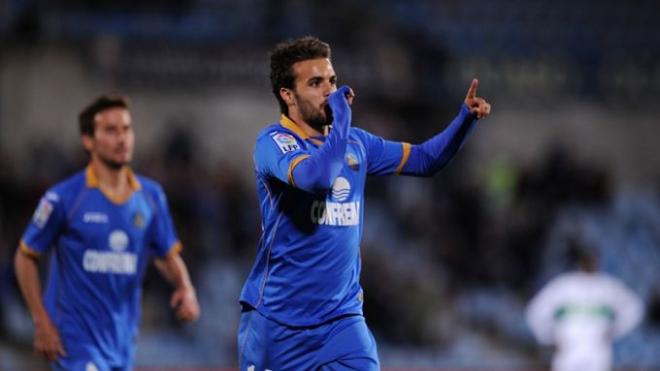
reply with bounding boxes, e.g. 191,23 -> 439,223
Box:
289,86 -> 353,192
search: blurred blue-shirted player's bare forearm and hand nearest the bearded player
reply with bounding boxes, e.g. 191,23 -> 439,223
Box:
154,252 -> 199,322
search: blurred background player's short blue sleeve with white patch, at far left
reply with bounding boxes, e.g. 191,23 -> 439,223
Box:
19,190 -> 66,257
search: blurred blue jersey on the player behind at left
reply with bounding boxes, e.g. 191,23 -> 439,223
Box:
20,166 -> 181,367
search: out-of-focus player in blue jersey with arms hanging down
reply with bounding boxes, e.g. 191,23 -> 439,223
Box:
15,96 -> 199,371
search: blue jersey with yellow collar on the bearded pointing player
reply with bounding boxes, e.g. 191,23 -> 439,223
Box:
241,116 -> 410,326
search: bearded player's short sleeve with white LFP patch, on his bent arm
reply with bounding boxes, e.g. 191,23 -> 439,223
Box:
254,130 -> 310,185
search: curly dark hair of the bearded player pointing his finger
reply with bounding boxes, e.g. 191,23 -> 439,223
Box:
270,36 -> 331,114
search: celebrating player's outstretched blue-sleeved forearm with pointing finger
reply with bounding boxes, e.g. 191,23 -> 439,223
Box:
401,79 -> 490,176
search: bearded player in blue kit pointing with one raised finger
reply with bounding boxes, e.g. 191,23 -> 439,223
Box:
238,36 -> 490,371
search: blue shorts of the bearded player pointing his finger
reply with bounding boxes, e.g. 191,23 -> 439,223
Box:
238,310 -> 380,371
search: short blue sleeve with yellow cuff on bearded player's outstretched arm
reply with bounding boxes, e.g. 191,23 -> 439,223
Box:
353,128 -> 410,175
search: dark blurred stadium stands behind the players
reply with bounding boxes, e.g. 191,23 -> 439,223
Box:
0,0 -> 660,370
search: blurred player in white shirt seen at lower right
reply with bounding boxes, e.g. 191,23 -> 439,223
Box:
526,247 -> 643,371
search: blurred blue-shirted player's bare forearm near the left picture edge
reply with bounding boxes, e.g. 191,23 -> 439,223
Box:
14,249 -> 66,361
